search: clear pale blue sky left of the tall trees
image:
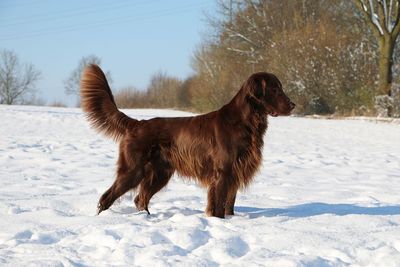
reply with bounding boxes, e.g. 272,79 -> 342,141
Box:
0,0 -> 215,105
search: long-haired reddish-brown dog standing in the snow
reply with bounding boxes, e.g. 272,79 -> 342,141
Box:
81,65 -> 295,218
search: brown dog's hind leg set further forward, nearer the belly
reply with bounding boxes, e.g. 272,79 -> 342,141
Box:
135,166 -> 173,214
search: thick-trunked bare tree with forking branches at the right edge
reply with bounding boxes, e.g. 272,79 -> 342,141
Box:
355,0 -> 400,116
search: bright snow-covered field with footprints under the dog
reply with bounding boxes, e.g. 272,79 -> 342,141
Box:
0,106 -> 400,267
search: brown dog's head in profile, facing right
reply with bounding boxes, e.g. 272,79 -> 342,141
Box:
246,72 -> 296,117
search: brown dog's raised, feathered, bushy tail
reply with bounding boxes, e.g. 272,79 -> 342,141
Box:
81,64 -> 138,140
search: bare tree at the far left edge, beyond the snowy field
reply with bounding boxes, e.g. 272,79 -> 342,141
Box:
0,50 -> 41,105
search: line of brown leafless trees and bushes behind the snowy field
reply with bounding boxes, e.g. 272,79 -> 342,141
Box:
0,0 -> 400,117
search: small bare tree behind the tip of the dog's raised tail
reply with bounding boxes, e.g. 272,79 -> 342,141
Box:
64,55 -> 112,96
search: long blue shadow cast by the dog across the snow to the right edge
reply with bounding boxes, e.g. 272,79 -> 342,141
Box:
235,203 -> 400,219
